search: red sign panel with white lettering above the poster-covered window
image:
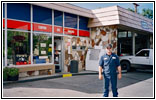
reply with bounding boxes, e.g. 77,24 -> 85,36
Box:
33,23 -> 52,32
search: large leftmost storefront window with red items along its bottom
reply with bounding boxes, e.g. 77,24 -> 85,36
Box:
7,31 -> 31,65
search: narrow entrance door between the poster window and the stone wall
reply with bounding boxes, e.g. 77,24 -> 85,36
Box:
54,36 -> 63,73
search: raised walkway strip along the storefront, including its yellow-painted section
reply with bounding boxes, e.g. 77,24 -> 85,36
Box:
3,71 -> 98,85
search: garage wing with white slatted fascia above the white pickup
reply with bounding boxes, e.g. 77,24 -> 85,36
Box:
88,6 -> 153,56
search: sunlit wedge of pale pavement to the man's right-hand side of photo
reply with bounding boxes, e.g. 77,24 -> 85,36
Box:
110,78 -> 154,98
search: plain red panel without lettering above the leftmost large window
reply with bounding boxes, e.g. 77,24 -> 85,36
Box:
7,19 -> 30,30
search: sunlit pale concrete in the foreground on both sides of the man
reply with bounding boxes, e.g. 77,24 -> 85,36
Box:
3,78 -> 153,98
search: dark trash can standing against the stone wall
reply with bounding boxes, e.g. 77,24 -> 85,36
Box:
70,60 -> 79,73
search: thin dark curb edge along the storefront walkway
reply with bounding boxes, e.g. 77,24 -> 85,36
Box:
3,72 -> 98,85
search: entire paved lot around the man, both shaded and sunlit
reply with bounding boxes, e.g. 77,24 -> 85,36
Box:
3,71 -> 153,98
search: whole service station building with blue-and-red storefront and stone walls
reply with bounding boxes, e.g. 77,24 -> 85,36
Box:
3,3 -> 153,77
